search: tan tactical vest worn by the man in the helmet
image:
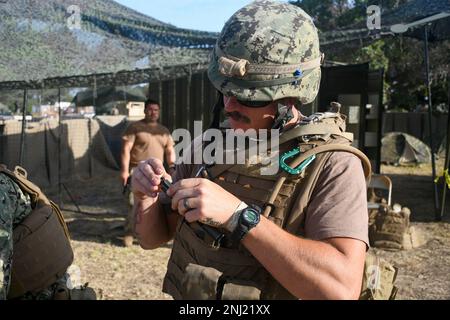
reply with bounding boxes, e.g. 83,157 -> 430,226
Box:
163,113 -> 394,300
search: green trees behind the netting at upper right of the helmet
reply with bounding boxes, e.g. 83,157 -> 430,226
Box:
291,0 -> 450,110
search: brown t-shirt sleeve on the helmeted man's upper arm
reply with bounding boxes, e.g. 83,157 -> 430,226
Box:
174,152 -> 369,247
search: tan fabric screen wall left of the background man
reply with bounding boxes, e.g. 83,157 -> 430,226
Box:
0,116 -> 129,187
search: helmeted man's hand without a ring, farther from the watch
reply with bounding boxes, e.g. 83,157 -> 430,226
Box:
131,158 -> 172,200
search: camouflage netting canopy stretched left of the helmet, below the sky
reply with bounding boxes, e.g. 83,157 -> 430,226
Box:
0,0 -> 217,89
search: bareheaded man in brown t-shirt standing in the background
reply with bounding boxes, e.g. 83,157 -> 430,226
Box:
120,99 -> 175,247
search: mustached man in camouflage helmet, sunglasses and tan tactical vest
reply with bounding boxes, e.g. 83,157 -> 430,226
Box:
132,0 -> 370,300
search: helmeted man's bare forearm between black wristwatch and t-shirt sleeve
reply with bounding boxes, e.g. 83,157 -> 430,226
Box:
243,218 -> 366,300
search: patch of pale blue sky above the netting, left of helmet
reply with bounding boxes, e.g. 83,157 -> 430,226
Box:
115,0 -> 288,32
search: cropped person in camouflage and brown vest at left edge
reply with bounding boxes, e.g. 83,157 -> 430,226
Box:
0,164 -> 96,300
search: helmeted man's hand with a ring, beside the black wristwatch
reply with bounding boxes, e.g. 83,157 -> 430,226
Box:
167,179 -> 241,228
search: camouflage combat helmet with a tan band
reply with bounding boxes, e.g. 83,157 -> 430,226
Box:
208,0 -> 323,104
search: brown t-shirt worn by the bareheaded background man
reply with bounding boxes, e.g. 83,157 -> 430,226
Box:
122,120 -> 174,167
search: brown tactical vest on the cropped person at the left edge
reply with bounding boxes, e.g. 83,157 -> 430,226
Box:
0,165 -> 73,299
